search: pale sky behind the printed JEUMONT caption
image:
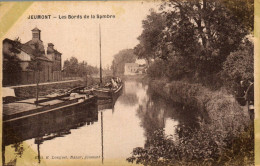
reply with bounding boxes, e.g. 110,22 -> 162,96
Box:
5,1 -> 159,67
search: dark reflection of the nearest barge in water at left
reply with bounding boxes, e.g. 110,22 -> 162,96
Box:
2,105 -> 98,165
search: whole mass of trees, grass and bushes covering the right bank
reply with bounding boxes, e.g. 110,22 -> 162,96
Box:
127,0 -> 254,166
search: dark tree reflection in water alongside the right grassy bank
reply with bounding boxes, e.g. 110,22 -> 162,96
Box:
137,84 -> 201,148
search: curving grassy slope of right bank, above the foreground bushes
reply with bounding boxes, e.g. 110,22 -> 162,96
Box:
149,80 -> 250,127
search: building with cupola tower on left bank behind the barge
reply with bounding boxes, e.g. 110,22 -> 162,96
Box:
3,28 -> 62,86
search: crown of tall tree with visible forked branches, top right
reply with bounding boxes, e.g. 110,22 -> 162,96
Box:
159,0 -> 248,74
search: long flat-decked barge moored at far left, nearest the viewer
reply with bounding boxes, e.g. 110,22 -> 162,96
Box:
3,88 -> 97,123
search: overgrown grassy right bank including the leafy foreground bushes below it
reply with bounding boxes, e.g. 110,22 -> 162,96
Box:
128,80 -> 254,165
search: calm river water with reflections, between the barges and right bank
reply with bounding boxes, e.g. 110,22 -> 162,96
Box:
4,79 -> 198,165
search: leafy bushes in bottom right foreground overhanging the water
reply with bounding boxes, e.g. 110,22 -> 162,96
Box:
127,124 -> 254,166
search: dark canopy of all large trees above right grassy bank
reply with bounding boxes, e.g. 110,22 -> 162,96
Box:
138,0 -> 253,85
